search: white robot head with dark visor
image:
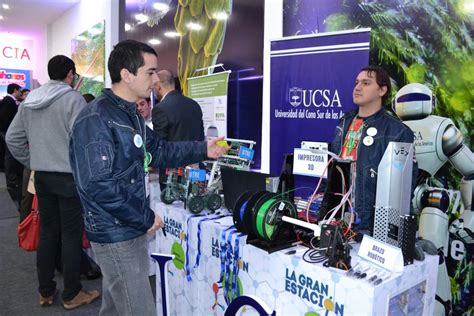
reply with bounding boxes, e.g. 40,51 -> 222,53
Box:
392,83 -> 436,121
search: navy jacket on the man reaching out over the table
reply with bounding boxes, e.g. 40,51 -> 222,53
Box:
70,89 -> 207,243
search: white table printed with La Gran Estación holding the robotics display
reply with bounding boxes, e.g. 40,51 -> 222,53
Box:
152,198 -> 438,316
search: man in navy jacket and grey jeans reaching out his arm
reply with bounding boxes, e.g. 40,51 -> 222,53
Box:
70,40 -> 225,315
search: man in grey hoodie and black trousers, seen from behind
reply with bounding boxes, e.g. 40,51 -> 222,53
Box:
6,55 -> 99,309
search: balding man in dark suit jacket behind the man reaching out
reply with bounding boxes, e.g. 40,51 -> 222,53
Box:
152,70 -> 204,190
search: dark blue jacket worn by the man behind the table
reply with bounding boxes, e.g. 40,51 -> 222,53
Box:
331,108 -> 418,231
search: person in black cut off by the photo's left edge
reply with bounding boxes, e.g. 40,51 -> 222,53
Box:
0,83 -> 23,203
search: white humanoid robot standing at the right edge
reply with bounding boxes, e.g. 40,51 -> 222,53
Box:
393,83 -> 474,315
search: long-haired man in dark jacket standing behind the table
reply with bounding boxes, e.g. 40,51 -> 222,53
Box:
331,66 -> 417,232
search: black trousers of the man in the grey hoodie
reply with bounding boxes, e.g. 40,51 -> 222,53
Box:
35,172 -> 84,301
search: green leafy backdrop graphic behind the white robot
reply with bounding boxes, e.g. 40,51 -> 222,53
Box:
325,0 -> 474,315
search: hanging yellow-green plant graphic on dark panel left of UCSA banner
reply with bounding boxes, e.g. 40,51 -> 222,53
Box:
174,0 -> 232,94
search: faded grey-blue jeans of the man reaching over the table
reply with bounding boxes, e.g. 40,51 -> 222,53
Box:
91,234 -> 156,316
